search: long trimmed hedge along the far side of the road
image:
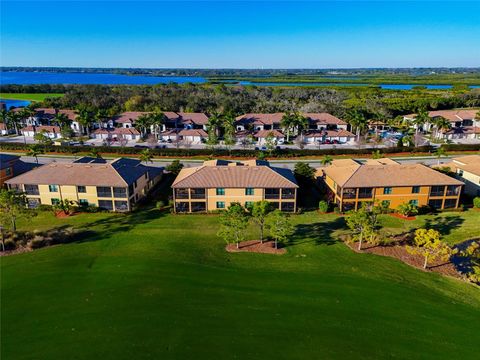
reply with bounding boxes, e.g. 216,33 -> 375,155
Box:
0,143 -> 480,158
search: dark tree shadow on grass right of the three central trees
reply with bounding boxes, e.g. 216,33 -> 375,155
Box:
287,217 -> 345,246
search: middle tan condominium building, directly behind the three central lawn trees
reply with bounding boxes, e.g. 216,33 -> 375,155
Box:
172,160 -> 298,212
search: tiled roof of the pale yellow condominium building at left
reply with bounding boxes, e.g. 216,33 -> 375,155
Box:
6,158 -> 162,187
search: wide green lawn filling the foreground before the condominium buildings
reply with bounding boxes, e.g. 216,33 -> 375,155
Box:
1,210 -> 480,360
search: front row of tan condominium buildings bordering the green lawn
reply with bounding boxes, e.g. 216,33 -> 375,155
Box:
4,154 -> 480,213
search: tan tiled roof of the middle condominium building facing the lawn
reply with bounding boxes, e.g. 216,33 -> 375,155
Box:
172,162 -> 298,188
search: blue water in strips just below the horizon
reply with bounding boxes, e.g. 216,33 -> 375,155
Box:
0,72 -> 480,90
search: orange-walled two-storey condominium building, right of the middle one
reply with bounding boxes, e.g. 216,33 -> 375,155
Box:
317,159 -> 463,211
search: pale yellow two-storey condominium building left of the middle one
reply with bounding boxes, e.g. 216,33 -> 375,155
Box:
6,157 -> 163,211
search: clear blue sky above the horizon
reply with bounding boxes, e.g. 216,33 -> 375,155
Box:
0,0 -> 480,68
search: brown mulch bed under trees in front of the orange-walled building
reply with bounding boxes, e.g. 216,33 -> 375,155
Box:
346,243 -> 462,279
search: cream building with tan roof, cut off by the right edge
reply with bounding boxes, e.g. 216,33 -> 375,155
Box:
442,155 -> 480,196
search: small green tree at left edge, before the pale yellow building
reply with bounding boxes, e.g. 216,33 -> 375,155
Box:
0,189 -> 32,231
